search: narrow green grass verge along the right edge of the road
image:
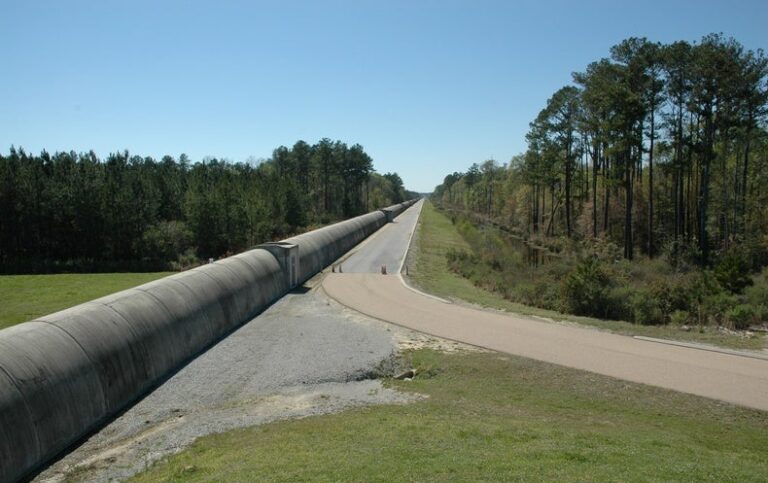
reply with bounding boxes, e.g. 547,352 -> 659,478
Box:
409,201 -> 766,350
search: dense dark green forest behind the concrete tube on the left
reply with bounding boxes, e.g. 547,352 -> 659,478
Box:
0,139 -> 407,273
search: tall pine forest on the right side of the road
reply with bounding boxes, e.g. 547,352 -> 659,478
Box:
433,34 -> 768,323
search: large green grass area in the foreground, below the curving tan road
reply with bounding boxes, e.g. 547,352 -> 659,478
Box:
135,350 -> 768,482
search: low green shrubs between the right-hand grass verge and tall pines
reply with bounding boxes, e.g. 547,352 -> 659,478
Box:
446,206 -> 768,327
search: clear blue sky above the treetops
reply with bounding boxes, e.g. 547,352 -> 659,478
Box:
0,0 -> 768,191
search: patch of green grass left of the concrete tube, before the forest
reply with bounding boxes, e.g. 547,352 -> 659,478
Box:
0,273 -> 170,329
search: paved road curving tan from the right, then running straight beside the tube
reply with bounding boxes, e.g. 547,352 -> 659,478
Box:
323,201 -> 768,410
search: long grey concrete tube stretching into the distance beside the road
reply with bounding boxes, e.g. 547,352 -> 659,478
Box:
0,200 -> 415,482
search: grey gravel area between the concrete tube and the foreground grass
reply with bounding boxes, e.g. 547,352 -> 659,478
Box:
35,277 -> 456,481
